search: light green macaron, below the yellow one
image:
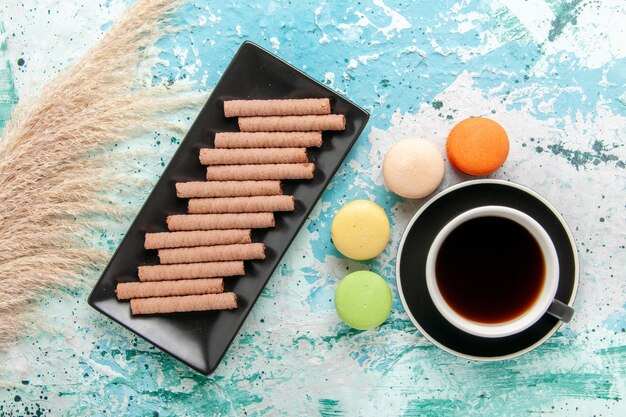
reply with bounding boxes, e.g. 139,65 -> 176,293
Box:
335,271 -> 392,330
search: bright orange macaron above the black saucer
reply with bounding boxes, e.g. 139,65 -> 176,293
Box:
446,117 -> 509,175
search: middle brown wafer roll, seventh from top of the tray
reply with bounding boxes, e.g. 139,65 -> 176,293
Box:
187,195 -> 295,214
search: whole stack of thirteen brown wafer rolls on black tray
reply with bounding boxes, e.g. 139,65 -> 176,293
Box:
116,98 -> 346,315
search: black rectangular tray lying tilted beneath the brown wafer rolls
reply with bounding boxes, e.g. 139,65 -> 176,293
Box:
89,42 -> 369,375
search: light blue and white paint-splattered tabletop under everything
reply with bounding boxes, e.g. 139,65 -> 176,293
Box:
0,0 -> 626,416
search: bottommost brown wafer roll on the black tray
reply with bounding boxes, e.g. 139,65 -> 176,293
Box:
130,292 -> 237,315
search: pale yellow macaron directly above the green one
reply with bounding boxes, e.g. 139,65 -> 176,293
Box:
330,200 -> 391,261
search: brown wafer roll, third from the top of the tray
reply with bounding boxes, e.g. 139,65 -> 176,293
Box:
214,132 -> 322,149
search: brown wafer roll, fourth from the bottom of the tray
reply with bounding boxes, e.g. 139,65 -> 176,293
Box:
159,243 -> 265,265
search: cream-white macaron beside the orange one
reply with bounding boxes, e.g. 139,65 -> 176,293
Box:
383,138 -> 444,198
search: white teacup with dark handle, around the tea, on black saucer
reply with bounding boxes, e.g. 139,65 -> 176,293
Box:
426,206 -> 574,337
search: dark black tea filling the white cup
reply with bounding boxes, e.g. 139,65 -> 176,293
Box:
435,216 -> 546,324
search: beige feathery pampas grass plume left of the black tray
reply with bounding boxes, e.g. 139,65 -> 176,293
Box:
0,0 -> 199,349
